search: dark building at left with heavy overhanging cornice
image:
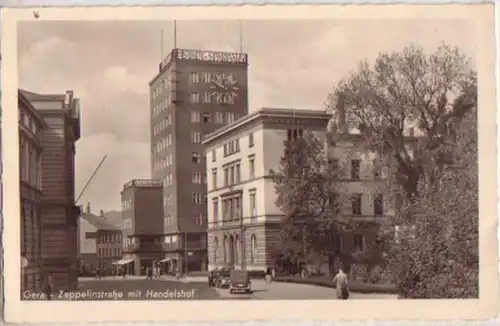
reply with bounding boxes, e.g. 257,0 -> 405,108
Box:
21,91 -> 80,290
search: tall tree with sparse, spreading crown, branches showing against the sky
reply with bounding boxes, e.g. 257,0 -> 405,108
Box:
327,44 -> 477,201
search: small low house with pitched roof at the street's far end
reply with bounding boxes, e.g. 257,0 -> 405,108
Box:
79,204 -> 122,275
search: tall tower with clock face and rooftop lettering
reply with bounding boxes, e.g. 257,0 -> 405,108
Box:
149,49 -> 248,271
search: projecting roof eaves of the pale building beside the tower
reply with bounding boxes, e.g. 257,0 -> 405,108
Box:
203,107 -> 331,144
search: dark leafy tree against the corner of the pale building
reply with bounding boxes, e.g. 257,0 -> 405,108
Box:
270,132 -> 348,274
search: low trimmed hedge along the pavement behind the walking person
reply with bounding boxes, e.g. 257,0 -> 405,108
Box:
274,276 -> 398,294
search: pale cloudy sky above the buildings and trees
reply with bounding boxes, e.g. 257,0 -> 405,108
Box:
18,19 -> 476,212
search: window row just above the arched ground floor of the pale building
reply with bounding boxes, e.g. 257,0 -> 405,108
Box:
212,190 -> 257,222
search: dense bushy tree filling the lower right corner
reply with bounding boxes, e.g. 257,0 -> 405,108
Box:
390,110 -> 479,298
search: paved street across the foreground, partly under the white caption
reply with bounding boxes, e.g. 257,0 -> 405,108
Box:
71,277 -> 396,300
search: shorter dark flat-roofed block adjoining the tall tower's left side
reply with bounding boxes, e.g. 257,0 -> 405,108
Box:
117,179 -> 163,275
